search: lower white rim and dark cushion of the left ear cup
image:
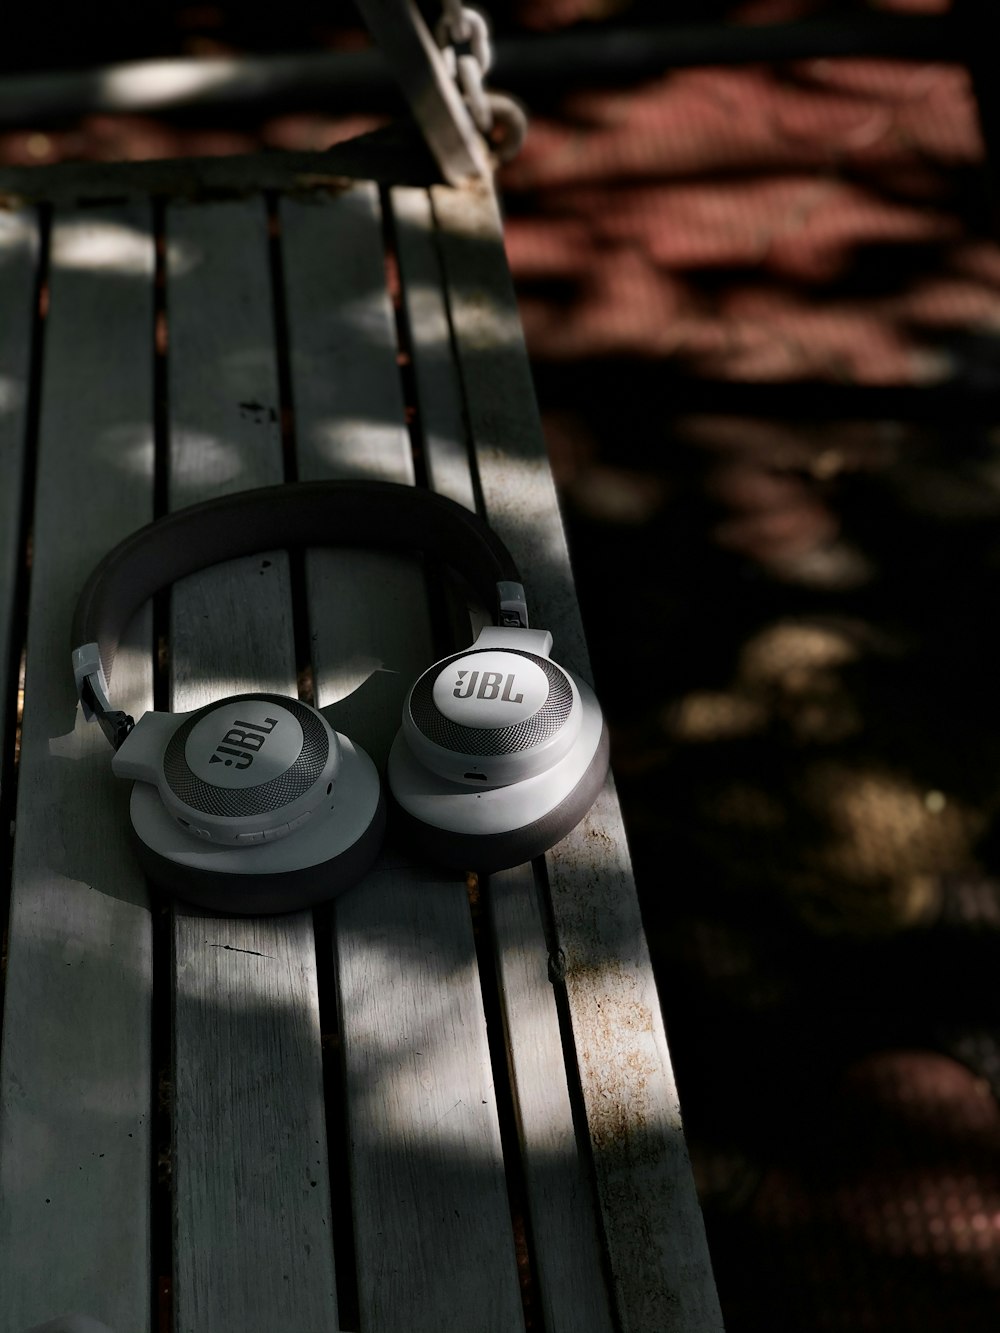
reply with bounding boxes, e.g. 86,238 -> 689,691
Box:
129,733 -> 385,914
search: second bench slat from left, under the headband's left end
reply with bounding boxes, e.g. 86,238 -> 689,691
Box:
0,209 -> 153,1330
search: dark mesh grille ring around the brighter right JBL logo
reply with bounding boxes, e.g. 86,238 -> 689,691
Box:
409,648 -> 573,758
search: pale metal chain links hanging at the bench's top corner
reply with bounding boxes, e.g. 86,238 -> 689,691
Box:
435,0 -> 528,163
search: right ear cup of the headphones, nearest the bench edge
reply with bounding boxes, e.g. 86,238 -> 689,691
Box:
388,653 -> 609,873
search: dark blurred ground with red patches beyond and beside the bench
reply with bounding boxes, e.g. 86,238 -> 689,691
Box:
0,0 -> 1000,1333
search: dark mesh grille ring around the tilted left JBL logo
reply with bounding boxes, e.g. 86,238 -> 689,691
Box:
163,694 -> 329,820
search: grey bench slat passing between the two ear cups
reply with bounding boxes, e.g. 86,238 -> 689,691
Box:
281,189 -> 523,1333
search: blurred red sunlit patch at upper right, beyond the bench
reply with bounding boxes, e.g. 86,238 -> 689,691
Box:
501,44 -> 1000,385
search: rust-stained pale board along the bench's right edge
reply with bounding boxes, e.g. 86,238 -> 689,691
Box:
432,187 -> 721,1333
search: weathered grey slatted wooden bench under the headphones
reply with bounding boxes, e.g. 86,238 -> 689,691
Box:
0,88 -> 721,1333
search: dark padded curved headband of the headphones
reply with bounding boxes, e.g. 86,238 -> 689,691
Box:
72,481 -> 527,751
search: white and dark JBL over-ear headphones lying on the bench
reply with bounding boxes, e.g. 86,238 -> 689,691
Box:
73,481 -> 608,914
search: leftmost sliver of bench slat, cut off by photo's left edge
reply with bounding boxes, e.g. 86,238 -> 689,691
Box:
0,211 -> 39,789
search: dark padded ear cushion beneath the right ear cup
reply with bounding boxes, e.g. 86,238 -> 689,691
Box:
391,726 -> 611,874
